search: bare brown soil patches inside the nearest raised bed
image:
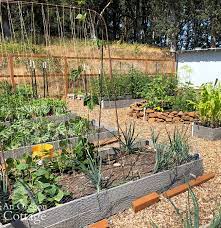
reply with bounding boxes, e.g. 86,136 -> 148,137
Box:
60,147 -> 155,199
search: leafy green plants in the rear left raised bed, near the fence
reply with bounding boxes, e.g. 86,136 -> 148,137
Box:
0,82 -> 68,122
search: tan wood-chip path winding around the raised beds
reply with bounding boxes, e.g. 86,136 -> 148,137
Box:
69,101 -> 221,228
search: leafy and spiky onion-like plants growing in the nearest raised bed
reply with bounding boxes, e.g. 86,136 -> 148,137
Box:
0,124 -> 198,223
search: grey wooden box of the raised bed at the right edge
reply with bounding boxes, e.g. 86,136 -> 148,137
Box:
192,123 -> 221,140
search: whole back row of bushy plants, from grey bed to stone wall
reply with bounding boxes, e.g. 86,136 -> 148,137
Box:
87,69 -> 198,112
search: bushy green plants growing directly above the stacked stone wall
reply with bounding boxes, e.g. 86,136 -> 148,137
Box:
140,76 -> 198,112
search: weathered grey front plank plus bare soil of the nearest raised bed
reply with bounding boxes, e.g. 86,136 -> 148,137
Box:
2,137 -> 203,228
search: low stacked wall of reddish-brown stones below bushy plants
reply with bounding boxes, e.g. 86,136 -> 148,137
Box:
128,101 -> 198,123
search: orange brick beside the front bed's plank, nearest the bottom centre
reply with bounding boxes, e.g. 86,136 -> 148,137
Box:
132,192 -> 160,213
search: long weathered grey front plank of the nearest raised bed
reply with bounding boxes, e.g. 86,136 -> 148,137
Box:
2,159 -> 203,228
